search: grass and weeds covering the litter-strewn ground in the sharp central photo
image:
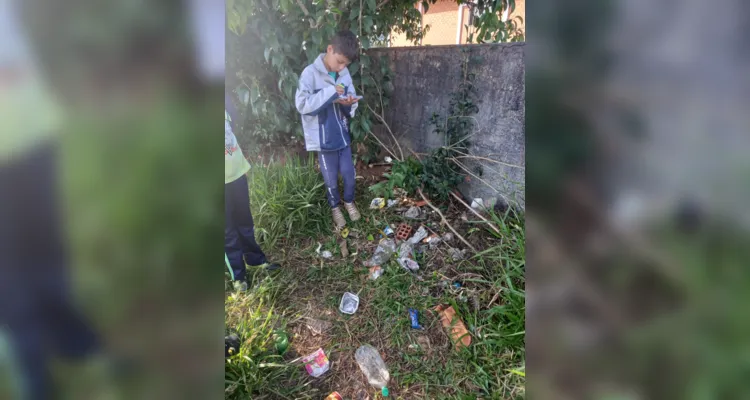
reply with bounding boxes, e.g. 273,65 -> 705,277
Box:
226,155 -> 525,400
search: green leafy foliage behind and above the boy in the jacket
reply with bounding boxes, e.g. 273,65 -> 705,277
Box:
226,0 -> 434,147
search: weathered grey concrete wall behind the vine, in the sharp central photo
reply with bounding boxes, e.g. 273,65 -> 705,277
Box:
369,43 -> 525,207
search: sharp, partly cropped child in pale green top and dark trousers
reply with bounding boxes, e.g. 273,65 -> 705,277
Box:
224,94 -> 279,292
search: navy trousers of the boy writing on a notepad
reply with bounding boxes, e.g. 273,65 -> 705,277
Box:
318,146 -> 356,208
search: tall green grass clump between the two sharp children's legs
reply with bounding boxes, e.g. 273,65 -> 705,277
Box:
248,154 -> 331,247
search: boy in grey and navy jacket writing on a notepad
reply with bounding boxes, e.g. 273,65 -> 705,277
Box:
295,31 -> 361,229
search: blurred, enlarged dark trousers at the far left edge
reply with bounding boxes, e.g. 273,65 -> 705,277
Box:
0,144 -> 99,399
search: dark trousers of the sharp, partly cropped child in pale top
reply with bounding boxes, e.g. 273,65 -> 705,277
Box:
224,175 -> 268,281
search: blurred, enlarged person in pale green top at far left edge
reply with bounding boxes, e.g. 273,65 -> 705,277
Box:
0,0 -> 99,399
